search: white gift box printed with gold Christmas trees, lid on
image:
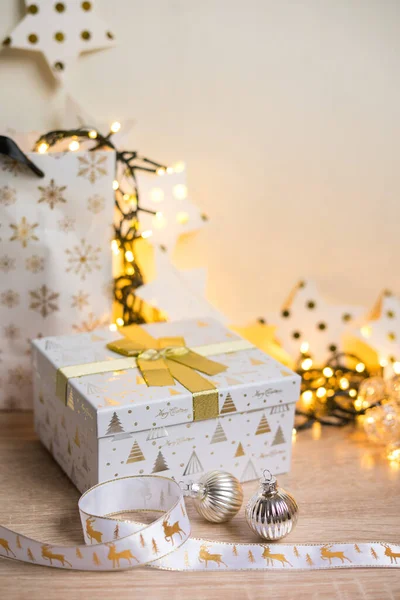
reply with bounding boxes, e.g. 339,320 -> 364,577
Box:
33,319 -> 300,492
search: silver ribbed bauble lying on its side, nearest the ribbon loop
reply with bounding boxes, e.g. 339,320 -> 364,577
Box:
184,471 -> 243,523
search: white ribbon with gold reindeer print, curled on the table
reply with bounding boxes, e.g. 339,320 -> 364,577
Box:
0,475 -> 400,571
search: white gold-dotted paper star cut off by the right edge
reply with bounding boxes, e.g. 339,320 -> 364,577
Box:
356,292 -> 400,374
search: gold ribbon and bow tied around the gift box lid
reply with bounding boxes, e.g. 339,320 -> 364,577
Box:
56,325 -> 253,421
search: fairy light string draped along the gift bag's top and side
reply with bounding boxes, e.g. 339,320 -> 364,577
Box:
34,121 -> 174,329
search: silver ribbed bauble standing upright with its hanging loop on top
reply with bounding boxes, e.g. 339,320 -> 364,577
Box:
246,471 -> 299,540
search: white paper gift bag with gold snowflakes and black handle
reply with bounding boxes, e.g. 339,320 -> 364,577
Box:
0,138 -> 115,409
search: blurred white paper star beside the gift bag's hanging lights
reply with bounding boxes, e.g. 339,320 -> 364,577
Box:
137,168 -> 207,253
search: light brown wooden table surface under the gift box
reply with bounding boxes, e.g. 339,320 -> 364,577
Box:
0,413 -> 400,600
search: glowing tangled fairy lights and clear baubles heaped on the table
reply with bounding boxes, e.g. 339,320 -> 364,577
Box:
293,342 -> 400,468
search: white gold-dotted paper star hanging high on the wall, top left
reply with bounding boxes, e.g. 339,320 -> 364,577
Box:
3,0 -> 115,80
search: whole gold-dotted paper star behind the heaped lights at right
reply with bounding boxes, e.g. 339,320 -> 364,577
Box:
266,281 -> 364,365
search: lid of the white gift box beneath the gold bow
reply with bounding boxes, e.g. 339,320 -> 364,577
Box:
33,319 -> 300,438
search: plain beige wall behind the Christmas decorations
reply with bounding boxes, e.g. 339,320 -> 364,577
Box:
0,0 -> 400,323
